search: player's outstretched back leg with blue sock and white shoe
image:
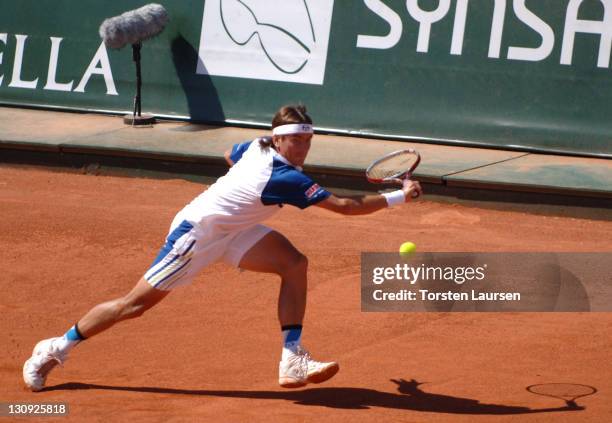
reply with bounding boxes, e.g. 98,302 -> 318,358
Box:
23,279 -> 168,391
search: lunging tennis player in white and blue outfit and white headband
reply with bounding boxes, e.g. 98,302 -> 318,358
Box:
23,106 -> 421,391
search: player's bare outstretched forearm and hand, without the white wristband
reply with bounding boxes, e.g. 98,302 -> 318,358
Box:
317,180 -> 423,215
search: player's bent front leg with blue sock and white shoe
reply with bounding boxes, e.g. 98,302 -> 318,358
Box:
239,231 -> 339,388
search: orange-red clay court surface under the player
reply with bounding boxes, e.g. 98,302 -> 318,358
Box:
0,166 -> 612,422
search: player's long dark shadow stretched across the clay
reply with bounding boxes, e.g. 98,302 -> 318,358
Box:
43,379 -> 584,415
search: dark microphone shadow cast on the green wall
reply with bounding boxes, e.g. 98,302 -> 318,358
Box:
171,34 -> 225,127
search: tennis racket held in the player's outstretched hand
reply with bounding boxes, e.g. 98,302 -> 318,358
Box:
366,148 -> 421,197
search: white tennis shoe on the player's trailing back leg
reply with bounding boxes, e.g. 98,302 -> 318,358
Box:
23,338 -> 68,392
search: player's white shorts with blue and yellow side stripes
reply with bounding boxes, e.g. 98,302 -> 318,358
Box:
144,220 -> 272,291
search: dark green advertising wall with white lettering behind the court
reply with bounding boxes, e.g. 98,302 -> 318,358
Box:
0,0 -> 612,157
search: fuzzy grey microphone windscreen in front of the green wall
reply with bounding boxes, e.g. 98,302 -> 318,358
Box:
99,3 -> 168,49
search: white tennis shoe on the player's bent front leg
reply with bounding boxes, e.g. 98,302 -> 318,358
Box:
278,347 -> 340,388
